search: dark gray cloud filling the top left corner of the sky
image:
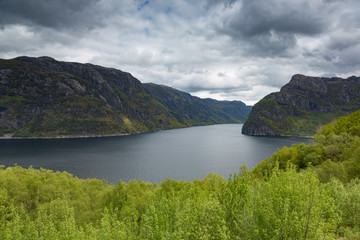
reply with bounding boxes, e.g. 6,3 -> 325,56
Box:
0,0 -> 105,28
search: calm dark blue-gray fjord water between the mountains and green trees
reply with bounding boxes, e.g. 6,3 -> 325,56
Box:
0,124 -> 309,183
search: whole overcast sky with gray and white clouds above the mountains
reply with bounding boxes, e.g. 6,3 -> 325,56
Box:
0,0 -> 360,105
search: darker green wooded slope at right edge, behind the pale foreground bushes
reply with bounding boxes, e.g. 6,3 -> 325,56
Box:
253,111 -> 360,182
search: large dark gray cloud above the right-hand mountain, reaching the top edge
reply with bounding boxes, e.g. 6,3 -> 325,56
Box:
213,0 -> 334,57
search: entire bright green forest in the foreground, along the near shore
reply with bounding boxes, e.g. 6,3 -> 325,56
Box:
0,111 -> 360,239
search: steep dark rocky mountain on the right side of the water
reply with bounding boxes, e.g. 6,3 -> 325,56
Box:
242,74 -> 360,136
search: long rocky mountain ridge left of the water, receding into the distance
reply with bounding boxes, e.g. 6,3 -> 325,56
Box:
0,57 -> 250,137
